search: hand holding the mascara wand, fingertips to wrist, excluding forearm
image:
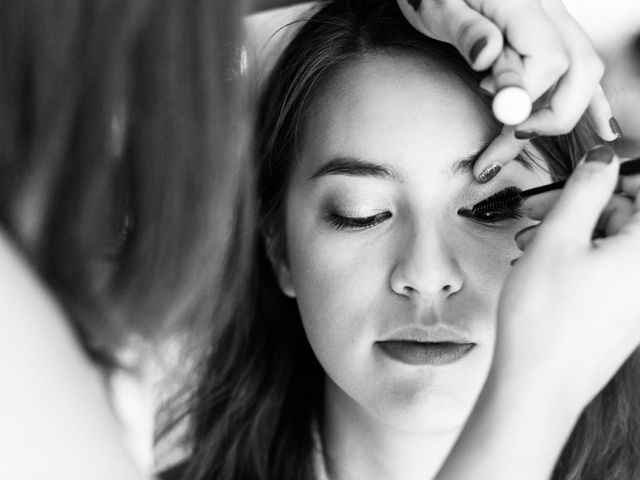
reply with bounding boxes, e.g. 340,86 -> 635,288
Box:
494,146 -> 640,409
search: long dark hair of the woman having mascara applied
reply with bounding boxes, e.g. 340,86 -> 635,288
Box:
179,0 -> 640,480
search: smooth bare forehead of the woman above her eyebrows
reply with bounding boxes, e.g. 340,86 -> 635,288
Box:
300,53 -> 497,176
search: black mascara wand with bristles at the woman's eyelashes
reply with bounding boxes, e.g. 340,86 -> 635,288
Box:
471,157 -> 640,217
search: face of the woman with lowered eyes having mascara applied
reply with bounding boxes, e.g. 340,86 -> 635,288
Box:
277,54 -> 550,432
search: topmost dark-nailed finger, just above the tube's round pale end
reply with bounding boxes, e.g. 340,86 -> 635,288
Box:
398,0 -> 504,70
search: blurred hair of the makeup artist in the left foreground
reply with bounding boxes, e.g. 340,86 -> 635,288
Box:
0,0 -> 252,365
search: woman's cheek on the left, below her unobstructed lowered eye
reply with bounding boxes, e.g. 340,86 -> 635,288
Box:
287,221 -> 388,359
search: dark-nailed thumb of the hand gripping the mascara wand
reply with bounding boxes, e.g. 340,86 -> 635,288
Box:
539,145 -> 620,246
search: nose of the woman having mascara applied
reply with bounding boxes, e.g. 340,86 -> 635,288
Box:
390,221 -> 463,298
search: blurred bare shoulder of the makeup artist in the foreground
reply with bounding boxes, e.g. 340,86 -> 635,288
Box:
0,230 -> 141,480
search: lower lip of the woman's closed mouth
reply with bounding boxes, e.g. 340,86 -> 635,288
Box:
376,340 -> 475,365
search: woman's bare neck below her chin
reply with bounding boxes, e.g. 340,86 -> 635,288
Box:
322,380 -> 460,480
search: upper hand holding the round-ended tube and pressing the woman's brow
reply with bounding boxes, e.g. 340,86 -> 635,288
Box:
398,0 -> 621,181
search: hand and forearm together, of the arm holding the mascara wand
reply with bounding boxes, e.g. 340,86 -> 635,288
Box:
435,146 -> 640,480
